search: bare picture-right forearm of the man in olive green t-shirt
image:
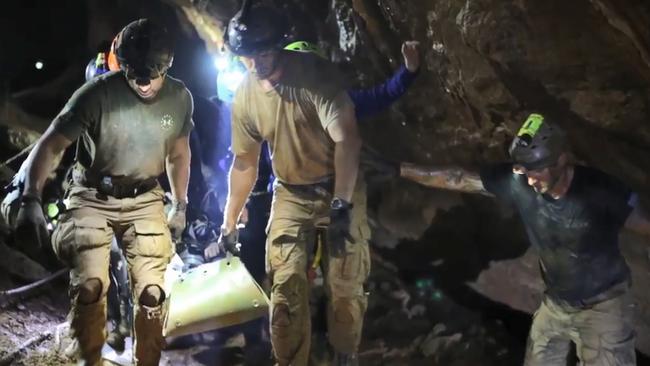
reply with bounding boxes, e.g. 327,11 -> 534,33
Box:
165,136 -> 192,203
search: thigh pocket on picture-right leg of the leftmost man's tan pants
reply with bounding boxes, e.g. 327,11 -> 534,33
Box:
133,221 -> 172,258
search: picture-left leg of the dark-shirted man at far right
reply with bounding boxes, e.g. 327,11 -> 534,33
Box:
524,297 -> 571,366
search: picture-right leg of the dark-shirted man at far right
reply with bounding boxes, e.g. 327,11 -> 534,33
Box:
575,293 -> 636,366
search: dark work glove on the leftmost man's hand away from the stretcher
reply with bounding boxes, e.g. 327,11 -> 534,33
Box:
15,195 -> 50,258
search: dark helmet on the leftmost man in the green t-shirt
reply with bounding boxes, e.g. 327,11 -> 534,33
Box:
115,19 -> 174,85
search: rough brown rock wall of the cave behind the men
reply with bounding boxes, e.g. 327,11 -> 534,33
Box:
5,0 -> 650,354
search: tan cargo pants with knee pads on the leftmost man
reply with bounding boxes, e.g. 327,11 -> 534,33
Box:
52,186 -> 173,366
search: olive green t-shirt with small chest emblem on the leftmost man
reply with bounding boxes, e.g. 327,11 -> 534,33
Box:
52,72 -> 194,180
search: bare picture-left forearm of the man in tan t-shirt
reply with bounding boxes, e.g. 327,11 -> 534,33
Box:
223,145 -> 261,233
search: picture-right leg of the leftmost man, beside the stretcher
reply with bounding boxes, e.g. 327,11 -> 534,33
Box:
122,191 -> 173,366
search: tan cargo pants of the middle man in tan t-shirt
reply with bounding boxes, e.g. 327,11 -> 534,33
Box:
266,179 -> 370,366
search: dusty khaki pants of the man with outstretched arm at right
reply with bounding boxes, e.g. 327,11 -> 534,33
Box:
524,292 -> 636,366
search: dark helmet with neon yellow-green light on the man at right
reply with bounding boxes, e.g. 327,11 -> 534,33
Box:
509,113 -> 566,170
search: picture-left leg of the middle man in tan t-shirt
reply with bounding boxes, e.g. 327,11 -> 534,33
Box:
267,186 -> 311,366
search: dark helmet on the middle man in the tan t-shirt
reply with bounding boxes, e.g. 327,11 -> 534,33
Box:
224,0 -> 288,56
